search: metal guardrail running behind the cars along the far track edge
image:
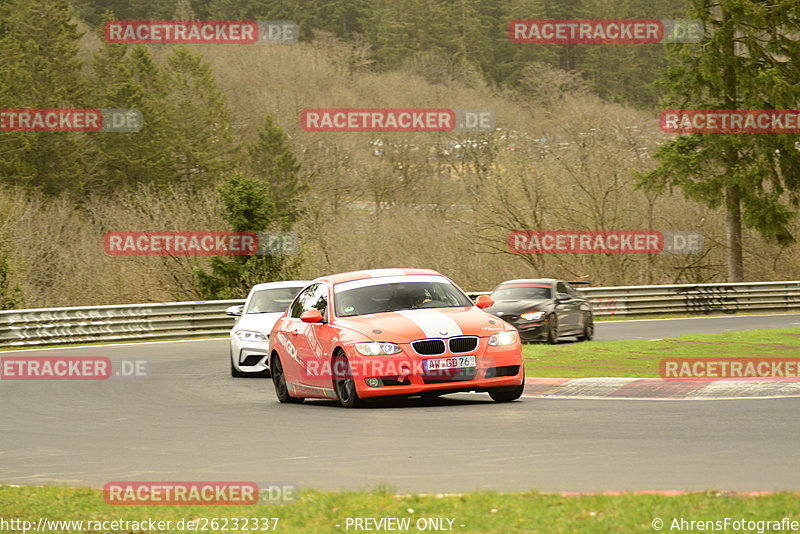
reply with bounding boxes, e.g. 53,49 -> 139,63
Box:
0,281 -> 800,347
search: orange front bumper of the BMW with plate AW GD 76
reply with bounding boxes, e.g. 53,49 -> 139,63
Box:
346,338 -> 525,398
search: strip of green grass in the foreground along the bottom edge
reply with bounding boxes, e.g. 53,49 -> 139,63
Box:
0,486 -> 800,534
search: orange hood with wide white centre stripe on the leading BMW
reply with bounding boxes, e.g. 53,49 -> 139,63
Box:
336,306 -> 505,343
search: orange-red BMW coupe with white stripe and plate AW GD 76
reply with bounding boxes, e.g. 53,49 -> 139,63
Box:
269,269 -> 525,408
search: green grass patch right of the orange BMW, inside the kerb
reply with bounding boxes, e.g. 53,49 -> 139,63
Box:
523,328 -> 800,378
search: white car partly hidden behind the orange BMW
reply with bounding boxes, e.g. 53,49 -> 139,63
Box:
225,280 -> 311,377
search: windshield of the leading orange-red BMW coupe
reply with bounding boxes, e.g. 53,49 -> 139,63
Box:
335,277 -> 473,317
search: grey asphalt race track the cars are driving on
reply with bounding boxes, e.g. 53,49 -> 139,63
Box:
0,315 -> 800,493
